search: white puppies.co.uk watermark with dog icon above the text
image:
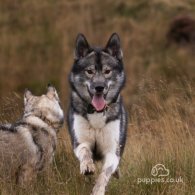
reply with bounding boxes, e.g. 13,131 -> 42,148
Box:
137,163 -> 183,184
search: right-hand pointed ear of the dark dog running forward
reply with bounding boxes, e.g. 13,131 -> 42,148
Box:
105,33 -> 123,59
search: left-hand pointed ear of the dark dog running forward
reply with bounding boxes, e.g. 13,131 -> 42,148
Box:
75,34 -> 90,59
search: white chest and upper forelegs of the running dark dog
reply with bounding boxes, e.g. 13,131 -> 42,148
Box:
73,113 -> 120,153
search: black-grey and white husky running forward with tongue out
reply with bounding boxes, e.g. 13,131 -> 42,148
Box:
68,33 -> 127,195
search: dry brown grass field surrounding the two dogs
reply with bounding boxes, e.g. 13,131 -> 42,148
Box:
0,0 -> 195,195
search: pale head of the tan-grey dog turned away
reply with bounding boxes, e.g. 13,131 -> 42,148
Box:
24,85 -> 64,127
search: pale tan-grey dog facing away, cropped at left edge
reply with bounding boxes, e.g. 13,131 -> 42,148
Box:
0,86 -> 64,185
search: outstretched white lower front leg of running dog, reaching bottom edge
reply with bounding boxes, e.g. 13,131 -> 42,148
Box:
92,153 -> 119,195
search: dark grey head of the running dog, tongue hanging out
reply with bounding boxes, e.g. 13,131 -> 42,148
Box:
70,33 -> 125,111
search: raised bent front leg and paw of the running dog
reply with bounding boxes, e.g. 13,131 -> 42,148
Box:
74,143 -> 95,175
